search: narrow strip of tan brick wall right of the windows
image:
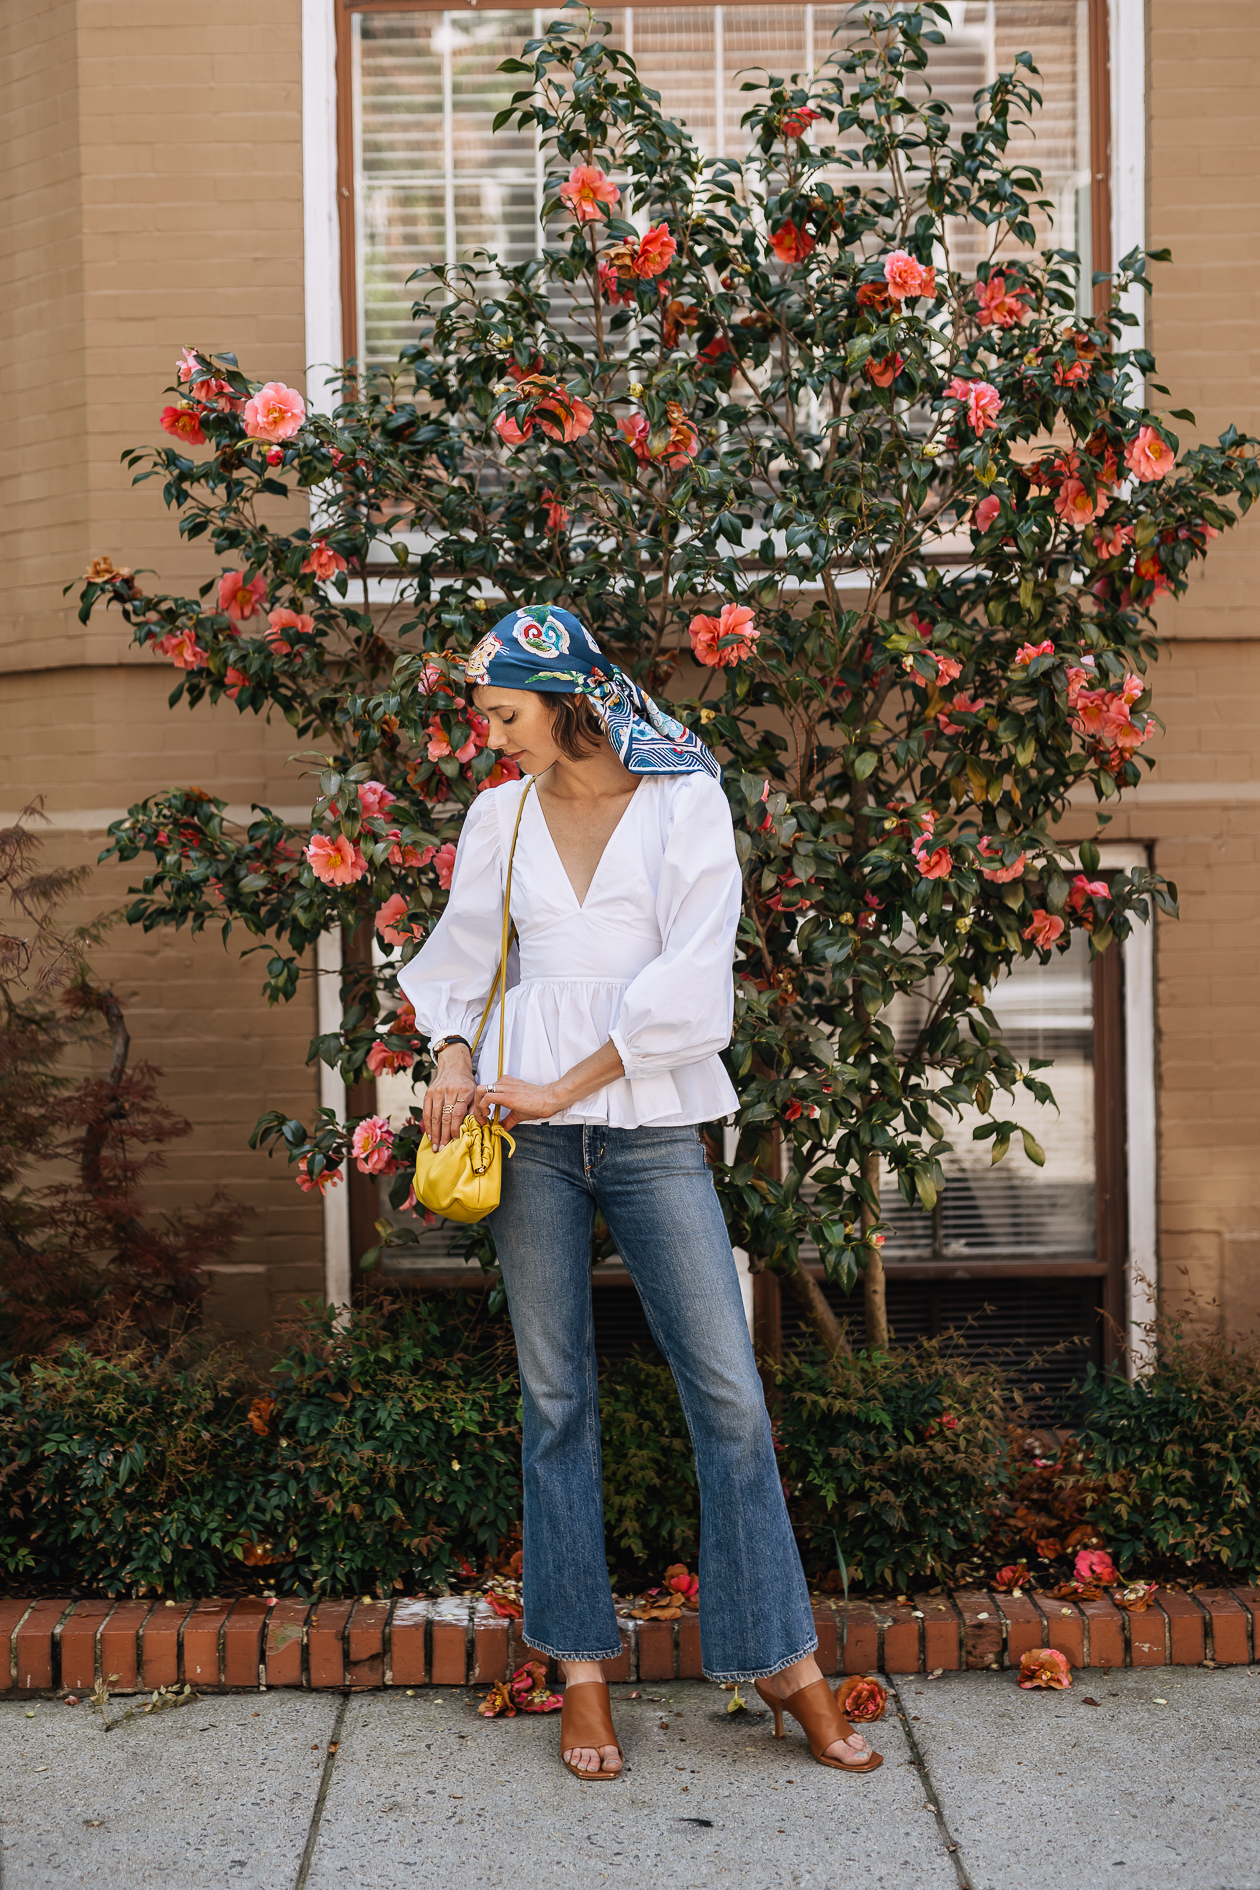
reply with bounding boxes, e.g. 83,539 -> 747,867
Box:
1140,0 -> 1260,1332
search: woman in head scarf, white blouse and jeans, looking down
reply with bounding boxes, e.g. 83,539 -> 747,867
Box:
400,607 -> 880,1778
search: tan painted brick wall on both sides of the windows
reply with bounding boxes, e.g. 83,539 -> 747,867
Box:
0,0 -> 1260,1360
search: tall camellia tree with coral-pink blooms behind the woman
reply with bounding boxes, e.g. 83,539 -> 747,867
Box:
83,4 -> 1260,1348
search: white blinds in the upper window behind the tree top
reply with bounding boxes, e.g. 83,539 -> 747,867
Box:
353,0 -> 1090,365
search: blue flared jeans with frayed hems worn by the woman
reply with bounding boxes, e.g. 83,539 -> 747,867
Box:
491,1123 -> 818,1680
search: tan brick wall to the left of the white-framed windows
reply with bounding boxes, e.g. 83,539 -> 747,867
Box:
0,0 -> 323,1331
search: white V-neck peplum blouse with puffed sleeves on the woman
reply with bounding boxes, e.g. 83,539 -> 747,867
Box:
399,773 -> 742,1128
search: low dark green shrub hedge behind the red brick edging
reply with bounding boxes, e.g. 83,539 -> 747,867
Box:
0,1297 -> 1260,1597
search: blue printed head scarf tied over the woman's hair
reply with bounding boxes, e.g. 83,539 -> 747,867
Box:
465,605 -> 722,781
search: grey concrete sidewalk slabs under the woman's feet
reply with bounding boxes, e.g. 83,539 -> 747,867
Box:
0,1667 -> 1260,1890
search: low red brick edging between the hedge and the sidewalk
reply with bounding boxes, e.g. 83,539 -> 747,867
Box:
0,1588 -> 1260,1697
